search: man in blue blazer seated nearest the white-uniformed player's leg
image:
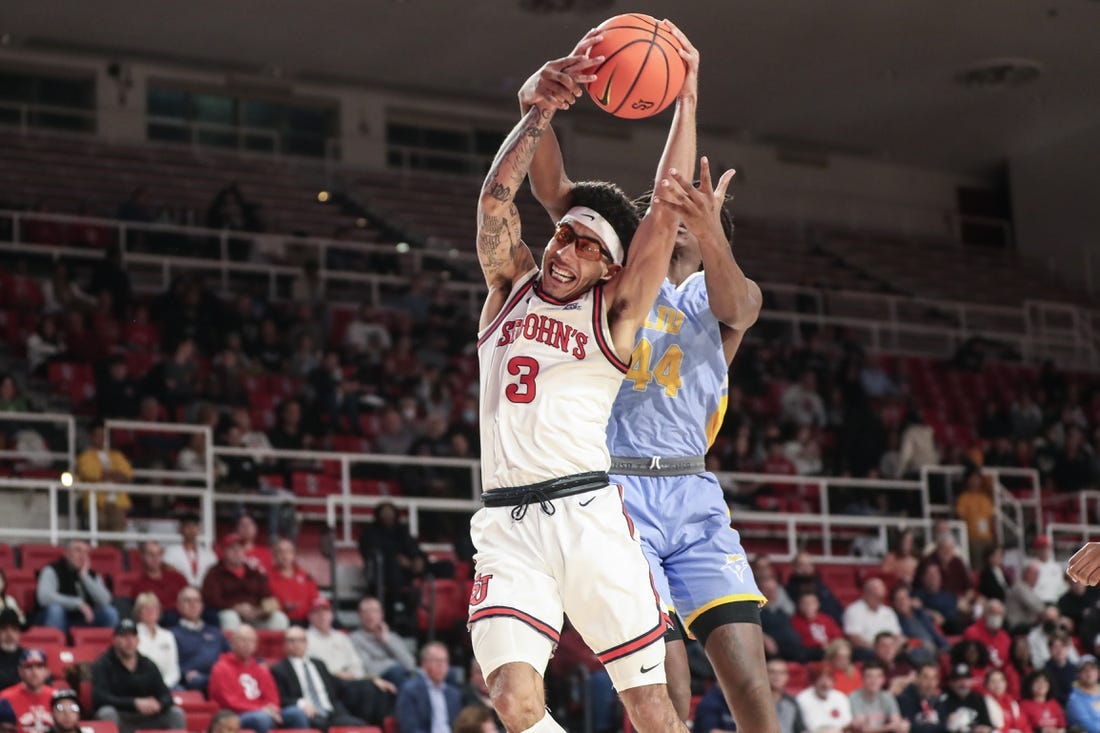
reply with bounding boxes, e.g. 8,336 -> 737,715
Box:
395,642 -> 462,733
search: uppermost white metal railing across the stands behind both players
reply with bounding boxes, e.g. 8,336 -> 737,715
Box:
0,210 -> 1100,360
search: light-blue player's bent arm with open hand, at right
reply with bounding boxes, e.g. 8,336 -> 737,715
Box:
667,156 -> 763,359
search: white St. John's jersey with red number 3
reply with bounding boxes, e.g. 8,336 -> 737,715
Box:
477,269 -> 627,491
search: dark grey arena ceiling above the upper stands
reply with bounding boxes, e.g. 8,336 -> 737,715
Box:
0,0 -> 1100,173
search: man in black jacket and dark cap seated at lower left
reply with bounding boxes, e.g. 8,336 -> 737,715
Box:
91,619 -> 186,733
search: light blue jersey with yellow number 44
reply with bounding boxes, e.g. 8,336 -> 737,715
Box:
607,272 -> 729,458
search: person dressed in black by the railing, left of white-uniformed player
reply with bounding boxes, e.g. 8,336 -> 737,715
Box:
359,502 -> 426,619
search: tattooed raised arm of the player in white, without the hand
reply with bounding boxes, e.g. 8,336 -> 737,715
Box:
477,107 -> 545,328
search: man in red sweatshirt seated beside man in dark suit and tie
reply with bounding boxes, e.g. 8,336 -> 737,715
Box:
208,624 -> 309,733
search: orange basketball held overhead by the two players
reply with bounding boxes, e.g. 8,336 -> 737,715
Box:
589,13 -> 688,120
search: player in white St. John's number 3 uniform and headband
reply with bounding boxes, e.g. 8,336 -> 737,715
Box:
470,25 -> 699,733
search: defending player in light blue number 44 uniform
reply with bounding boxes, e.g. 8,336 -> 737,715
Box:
519,41 -> 778,732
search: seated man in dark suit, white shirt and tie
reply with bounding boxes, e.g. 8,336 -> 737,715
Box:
272,626 -> 366,731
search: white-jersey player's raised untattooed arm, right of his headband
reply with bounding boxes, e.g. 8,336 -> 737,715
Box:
607,21 -> 699,354
